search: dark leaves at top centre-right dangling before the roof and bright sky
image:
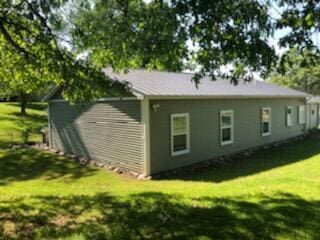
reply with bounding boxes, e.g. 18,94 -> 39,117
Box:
173,0 -> 276,80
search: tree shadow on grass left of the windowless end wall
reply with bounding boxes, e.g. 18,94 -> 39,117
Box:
0,149 -> 96,186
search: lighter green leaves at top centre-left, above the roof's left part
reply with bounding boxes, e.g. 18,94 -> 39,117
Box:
72,0 -> 187,71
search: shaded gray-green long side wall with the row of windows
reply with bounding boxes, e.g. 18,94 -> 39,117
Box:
150,98 -> 305,173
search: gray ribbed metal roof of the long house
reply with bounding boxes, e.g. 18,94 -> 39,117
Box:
103,68 -> 309,98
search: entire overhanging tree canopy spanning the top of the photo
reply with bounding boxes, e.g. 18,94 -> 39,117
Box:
0,0 -> 320,101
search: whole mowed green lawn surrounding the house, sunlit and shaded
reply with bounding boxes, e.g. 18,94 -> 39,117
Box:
0,104 -> 320,240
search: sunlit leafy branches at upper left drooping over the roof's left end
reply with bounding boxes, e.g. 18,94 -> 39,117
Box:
0,0 -> 128,106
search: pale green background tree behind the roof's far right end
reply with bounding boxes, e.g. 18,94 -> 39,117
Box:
269,49 -> 320,95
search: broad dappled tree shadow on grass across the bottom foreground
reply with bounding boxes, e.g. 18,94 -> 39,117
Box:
0,192 -> 320,240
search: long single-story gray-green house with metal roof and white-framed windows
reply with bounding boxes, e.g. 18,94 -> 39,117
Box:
46,69 -> 313,176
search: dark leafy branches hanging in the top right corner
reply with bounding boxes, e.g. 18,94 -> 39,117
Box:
274,0 -> 320,75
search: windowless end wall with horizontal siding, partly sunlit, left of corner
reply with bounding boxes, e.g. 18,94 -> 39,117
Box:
49,100 -> 143,172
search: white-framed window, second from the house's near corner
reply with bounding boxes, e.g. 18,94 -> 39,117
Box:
220,110 -> 233,145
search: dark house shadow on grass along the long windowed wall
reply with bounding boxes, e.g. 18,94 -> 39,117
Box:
164,138 -> 320,183
